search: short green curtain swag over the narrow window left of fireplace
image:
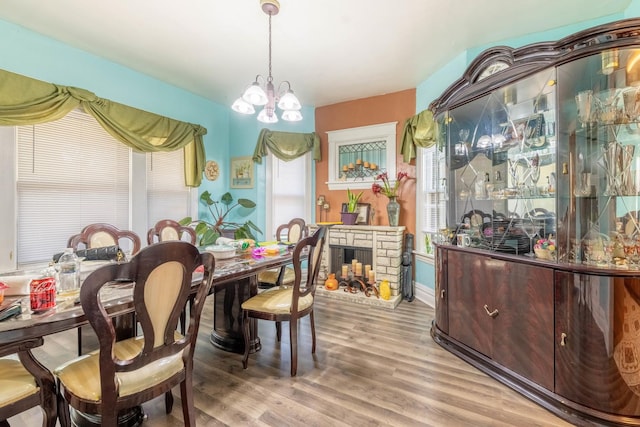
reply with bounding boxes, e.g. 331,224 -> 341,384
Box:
253,128 -> 321,164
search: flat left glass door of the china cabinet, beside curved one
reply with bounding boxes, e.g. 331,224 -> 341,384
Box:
437,68 -> 557,259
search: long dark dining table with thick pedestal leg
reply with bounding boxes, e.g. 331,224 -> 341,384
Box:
0,247 -> 292,425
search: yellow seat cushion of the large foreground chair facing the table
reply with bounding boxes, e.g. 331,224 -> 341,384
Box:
54,333 -> 184,402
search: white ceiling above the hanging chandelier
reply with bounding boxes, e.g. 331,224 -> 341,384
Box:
0,0 -> 631,107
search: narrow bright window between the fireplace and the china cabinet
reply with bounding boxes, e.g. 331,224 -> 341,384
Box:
416,145 -> 447,255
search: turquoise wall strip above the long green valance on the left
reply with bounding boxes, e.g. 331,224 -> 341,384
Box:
0,20 -> 229,154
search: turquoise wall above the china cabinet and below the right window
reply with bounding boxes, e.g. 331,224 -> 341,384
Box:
415,8 -> 640,296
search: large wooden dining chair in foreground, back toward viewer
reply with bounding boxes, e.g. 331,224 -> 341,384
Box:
54,241 -> 215,427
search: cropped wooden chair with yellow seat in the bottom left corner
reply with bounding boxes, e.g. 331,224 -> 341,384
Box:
0,338 -> 57,427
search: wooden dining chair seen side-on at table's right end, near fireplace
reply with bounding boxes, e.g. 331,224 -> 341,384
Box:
242,227 -> 326,377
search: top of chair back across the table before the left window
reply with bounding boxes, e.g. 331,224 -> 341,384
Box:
67,223 -> 141,255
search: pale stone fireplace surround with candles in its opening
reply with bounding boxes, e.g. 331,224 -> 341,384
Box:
309,224 -> 405,308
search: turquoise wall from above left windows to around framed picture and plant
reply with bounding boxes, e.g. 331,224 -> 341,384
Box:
0,20 -> 315,237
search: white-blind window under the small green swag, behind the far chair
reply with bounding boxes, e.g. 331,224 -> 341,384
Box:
264,152 -> 313,240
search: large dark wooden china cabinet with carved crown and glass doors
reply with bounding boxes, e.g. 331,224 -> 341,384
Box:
430,19 -> 640,426
